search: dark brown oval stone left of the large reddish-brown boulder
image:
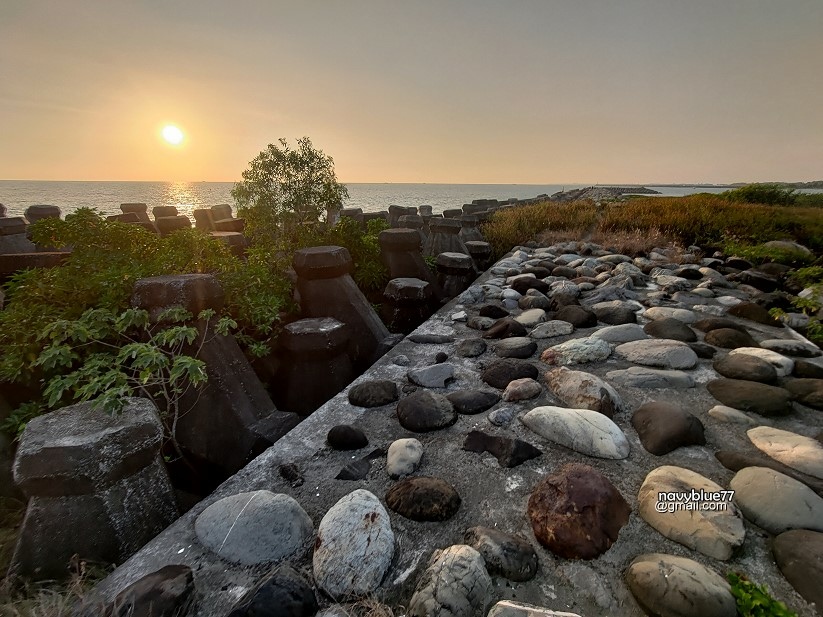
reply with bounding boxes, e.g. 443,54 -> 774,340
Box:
386,476 -> 461,521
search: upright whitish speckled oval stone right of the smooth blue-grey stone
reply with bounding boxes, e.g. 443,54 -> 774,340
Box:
312,489 -> 394,598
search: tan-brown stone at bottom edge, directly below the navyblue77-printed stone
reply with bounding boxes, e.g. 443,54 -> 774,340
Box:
626,553 -> 737,617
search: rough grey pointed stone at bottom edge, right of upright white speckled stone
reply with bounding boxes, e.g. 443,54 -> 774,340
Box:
408,545 -> 492,617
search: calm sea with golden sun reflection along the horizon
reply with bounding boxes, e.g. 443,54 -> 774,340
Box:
0,180 -> 812,216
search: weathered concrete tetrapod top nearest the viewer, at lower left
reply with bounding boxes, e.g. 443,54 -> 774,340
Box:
10,398 -> 178,579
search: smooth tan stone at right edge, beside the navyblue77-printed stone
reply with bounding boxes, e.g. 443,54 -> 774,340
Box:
729,467 -> 823,535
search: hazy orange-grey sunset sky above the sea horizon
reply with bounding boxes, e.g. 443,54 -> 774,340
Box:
0,0 -> 823,183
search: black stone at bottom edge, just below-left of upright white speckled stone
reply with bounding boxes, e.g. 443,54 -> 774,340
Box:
229,565 -> 318,617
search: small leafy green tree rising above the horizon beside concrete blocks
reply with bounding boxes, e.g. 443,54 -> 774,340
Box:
231,137 -> 349,242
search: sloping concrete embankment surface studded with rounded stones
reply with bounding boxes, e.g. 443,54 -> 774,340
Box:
85,238 -> 823,617
